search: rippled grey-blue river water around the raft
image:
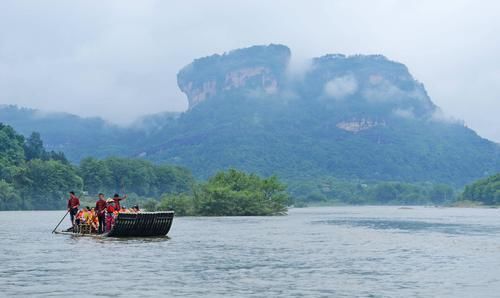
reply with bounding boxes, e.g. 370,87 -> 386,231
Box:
0,207 -> 500,297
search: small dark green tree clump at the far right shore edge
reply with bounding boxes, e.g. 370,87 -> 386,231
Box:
460,173 -> 500,205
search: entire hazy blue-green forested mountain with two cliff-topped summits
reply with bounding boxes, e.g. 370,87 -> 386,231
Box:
0,45 -> 500,186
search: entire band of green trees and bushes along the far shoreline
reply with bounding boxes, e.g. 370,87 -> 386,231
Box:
0,123 -> 500,216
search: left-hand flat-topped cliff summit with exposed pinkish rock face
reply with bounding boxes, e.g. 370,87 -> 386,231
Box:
177,45 -> 290,109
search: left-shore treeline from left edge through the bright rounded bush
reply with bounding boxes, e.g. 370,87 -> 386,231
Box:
0,124 -> 289,215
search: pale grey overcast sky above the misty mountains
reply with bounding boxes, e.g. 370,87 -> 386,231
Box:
0,0 -> 500,142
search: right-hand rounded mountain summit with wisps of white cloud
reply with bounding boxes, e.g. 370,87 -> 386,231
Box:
303,54 -> 436,118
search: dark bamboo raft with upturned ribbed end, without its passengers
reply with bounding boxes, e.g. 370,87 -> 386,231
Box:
54,211 -> 174,238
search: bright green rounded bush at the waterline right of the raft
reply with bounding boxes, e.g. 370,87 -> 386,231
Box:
152,169 -> 288,216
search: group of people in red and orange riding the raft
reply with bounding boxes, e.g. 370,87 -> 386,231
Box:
68,191 -> 140,234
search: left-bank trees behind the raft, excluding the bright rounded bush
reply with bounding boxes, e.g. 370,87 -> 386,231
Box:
0,124 -> 194,210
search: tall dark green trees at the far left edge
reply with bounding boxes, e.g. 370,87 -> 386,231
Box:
0,124 -> 83,210
